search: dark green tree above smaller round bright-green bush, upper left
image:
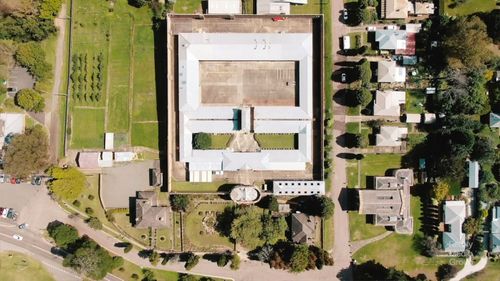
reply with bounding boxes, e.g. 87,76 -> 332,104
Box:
15,42 -> 51,80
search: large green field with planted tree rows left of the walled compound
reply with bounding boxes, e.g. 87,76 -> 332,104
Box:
70,0 -> 158,149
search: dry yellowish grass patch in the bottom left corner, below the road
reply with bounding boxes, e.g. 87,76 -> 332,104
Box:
0,252 -> 55,281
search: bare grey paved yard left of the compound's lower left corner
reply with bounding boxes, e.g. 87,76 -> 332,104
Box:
101,161 -> 160,209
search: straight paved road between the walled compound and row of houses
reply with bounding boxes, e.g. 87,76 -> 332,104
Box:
331,0 -> 353,280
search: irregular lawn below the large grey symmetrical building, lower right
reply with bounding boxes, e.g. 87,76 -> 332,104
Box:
353,196 -> 459,278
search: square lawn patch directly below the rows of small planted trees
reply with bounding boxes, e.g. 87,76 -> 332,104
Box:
70,108 -> 104,149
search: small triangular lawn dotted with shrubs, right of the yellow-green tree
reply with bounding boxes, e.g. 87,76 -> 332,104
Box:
66,175 -> 115,229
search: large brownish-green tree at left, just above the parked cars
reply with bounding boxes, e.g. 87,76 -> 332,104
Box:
4,125 -> 49,178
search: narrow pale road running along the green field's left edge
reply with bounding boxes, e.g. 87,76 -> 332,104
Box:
45,4 -> 66,163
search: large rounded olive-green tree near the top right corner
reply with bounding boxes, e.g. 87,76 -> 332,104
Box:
443,16 -> 491,69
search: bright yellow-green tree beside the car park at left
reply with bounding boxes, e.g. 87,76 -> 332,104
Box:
49,167 -> 87,201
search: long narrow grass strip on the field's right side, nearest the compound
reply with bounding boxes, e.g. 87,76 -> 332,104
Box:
132,25 -> 158,122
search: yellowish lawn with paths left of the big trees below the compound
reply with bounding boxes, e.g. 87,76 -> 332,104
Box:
184,203 -> 233,250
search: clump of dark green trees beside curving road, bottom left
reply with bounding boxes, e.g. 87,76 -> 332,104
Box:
47,221 -> 123,280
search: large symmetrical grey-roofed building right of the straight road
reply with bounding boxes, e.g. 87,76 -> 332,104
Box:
359,169 -> 414,234
